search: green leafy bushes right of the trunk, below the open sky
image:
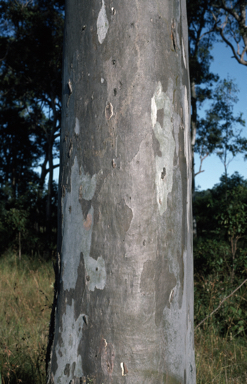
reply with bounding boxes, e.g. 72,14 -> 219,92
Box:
194,173 -> 247,337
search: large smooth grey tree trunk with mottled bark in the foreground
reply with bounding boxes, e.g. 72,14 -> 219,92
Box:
48,0 -> 195,384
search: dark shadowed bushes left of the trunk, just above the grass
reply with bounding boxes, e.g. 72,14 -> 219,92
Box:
0,183 -> 57,256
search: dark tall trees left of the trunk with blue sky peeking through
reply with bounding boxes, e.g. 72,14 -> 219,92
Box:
0,0 -> 64,255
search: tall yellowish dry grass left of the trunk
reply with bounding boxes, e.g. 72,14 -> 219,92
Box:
0,254 -> 54,384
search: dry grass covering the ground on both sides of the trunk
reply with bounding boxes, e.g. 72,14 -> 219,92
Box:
0,250 -> 247,384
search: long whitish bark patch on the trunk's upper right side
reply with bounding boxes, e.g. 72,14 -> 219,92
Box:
151,80 -> 175,215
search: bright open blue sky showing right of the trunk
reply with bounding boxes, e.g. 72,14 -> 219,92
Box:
195,43 -> 247,190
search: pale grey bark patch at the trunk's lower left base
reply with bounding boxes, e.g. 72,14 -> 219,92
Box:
54,299 -> 85,384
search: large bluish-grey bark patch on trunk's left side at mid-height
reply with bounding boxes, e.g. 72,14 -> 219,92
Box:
61,157 -> 106,291
